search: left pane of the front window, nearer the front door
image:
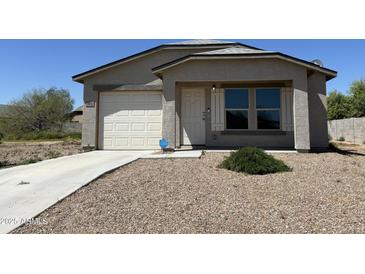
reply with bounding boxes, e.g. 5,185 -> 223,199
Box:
224,88 -> 249,129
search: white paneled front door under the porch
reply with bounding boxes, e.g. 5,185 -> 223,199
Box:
181,88 -> 205,145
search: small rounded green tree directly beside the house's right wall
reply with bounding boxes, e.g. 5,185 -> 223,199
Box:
327,90 -> 353,120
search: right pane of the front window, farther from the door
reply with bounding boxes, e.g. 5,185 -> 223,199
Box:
256,88 -> 280,129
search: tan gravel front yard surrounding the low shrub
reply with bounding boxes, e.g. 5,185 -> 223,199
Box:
14,148 -> 365,233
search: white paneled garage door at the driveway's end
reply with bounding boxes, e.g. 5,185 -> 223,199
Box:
99,91 -> 162,149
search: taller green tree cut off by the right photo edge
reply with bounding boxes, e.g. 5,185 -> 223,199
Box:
350,79 -> 365,117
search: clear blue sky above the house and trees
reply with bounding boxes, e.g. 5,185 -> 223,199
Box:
0,39 -> 365,107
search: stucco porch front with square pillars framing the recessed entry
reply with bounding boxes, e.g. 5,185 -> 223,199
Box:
163,59 -> 310,150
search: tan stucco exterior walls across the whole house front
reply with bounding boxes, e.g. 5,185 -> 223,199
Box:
82,47 -> 327,150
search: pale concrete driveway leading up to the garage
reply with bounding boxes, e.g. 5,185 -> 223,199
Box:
0,151 -> 153,233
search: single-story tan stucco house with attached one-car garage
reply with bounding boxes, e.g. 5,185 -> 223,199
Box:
73,40 -> 337,152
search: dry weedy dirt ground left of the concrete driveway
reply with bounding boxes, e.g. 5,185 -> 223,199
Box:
0,141 -> 81,168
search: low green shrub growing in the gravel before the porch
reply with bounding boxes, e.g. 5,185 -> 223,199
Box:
218,147 -> 291,175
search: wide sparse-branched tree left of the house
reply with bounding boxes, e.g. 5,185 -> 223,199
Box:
3,88 -> 74,135
